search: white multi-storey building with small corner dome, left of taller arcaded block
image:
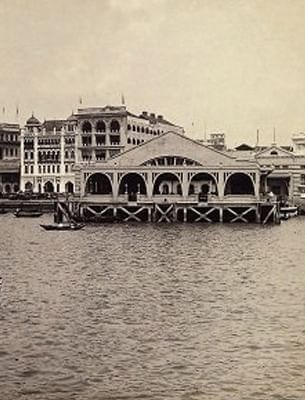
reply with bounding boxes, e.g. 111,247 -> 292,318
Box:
20,115 -> 77,193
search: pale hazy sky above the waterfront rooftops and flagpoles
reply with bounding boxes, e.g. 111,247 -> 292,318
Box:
0,0 -> 305,146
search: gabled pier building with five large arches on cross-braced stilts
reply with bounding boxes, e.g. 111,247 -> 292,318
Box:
72,132 -> 275,222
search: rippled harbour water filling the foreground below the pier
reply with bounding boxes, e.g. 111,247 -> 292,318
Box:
0,214 -> 305,400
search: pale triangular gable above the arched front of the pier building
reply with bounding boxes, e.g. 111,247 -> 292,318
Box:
107,131 -> 255,167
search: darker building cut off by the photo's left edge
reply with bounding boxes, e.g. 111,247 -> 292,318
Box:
0,123 -> 20,194
